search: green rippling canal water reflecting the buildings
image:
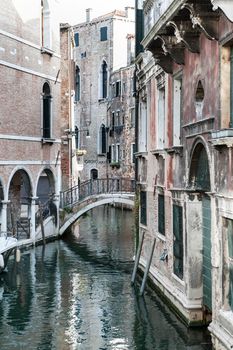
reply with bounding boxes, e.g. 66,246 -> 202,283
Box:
0,206 -> 211,350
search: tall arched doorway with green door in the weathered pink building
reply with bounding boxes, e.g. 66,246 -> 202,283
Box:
189,143 -> 212,311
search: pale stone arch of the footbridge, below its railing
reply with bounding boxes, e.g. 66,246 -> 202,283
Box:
59,193 -> 134,235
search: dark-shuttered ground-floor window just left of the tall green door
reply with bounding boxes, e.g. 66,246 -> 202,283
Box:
173,204 -> 184,279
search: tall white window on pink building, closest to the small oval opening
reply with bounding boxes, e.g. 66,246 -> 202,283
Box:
173,78 -> 182,146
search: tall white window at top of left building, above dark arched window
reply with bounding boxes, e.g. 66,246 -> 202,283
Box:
41,0 -> 52,49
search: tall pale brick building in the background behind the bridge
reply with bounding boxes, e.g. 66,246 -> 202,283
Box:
73,8 -> 135,180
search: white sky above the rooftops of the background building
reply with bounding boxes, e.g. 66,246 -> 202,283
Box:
60,0 -> 135,25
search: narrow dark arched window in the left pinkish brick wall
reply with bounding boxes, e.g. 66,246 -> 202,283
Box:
43,83 -> 52,139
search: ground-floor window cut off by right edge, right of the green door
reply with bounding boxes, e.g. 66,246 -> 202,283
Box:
223,218 -> 233,311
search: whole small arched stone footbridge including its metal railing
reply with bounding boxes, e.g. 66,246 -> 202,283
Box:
59,178 -> 135,235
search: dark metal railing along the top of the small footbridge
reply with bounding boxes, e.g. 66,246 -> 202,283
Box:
60,178 -> 135,208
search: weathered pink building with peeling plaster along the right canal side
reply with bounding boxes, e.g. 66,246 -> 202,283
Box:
136,0 -> 233,350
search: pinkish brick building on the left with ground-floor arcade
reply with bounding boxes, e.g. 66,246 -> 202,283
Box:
0,0 -> 61,240
